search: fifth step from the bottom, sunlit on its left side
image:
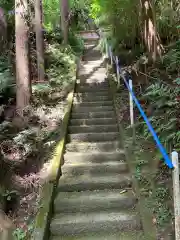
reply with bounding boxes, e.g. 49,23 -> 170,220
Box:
62,161 -> 128,178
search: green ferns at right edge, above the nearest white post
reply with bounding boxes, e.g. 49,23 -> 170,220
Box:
139,81 -> 180,150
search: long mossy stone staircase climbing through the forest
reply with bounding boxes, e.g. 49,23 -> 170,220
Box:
50,40 -> 143,240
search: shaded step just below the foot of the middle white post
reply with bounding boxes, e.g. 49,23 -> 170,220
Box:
68,124 -> 118,134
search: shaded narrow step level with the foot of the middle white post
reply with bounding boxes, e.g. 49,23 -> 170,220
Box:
70,118 -> 117,126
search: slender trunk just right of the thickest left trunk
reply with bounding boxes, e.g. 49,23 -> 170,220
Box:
35,0 -> 45,82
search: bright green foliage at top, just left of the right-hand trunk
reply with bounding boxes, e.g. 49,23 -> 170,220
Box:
91,0 -> 138,47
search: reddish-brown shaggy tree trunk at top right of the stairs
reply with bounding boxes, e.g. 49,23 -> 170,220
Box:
140,0 -> 163,62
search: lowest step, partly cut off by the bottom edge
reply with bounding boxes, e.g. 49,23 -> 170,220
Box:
50,231 -> 147,240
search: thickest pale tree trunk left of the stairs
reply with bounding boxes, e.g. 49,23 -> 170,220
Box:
15,0 -> 31,116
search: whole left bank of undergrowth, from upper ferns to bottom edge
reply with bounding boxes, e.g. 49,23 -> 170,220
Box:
0,27 -> 84,237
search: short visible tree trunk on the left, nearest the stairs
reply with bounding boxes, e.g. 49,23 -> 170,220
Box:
60,0 -> 69,44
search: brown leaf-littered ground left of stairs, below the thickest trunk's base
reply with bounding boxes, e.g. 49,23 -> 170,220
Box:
0,81 -> 74,240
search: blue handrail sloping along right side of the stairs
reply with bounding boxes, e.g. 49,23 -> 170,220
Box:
103,34 -> 174,168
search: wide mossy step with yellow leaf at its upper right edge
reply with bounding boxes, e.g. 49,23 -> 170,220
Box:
54,189 -> 136,213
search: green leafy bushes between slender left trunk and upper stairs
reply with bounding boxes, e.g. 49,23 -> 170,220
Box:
32,42 -> 76,104
